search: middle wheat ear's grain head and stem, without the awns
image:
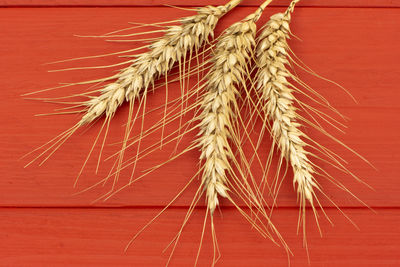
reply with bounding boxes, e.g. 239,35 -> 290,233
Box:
198,1 -> 271,217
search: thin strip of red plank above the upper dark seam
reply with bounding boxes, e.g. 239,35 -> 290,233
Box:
0,0 -> 400,7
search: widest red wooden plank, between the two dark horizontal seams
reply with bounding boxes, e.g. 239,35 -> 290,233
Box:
0,5 -> 400,207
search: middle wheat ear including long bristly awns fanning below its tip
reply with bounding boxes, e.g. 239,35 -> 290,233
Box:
192,0 -> 290,266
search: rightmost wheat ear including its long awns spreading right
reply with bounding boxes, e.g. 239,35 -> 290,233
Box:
256,0 -> 373,253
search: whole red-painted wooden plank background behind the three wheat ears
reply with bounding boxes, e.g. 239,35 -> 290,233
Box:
0,0 -> 400,266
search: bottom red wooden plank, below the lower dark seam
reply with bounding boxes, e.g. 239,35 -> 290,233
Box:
0,209 -> 400,267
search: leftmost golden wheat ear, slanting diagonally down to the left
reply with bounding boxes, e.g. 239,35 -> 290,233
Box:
26,0 -> 241,172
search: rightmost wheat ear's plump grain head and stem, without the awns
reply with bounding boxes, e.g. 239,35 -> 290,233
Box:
256,0 -> 318,211
